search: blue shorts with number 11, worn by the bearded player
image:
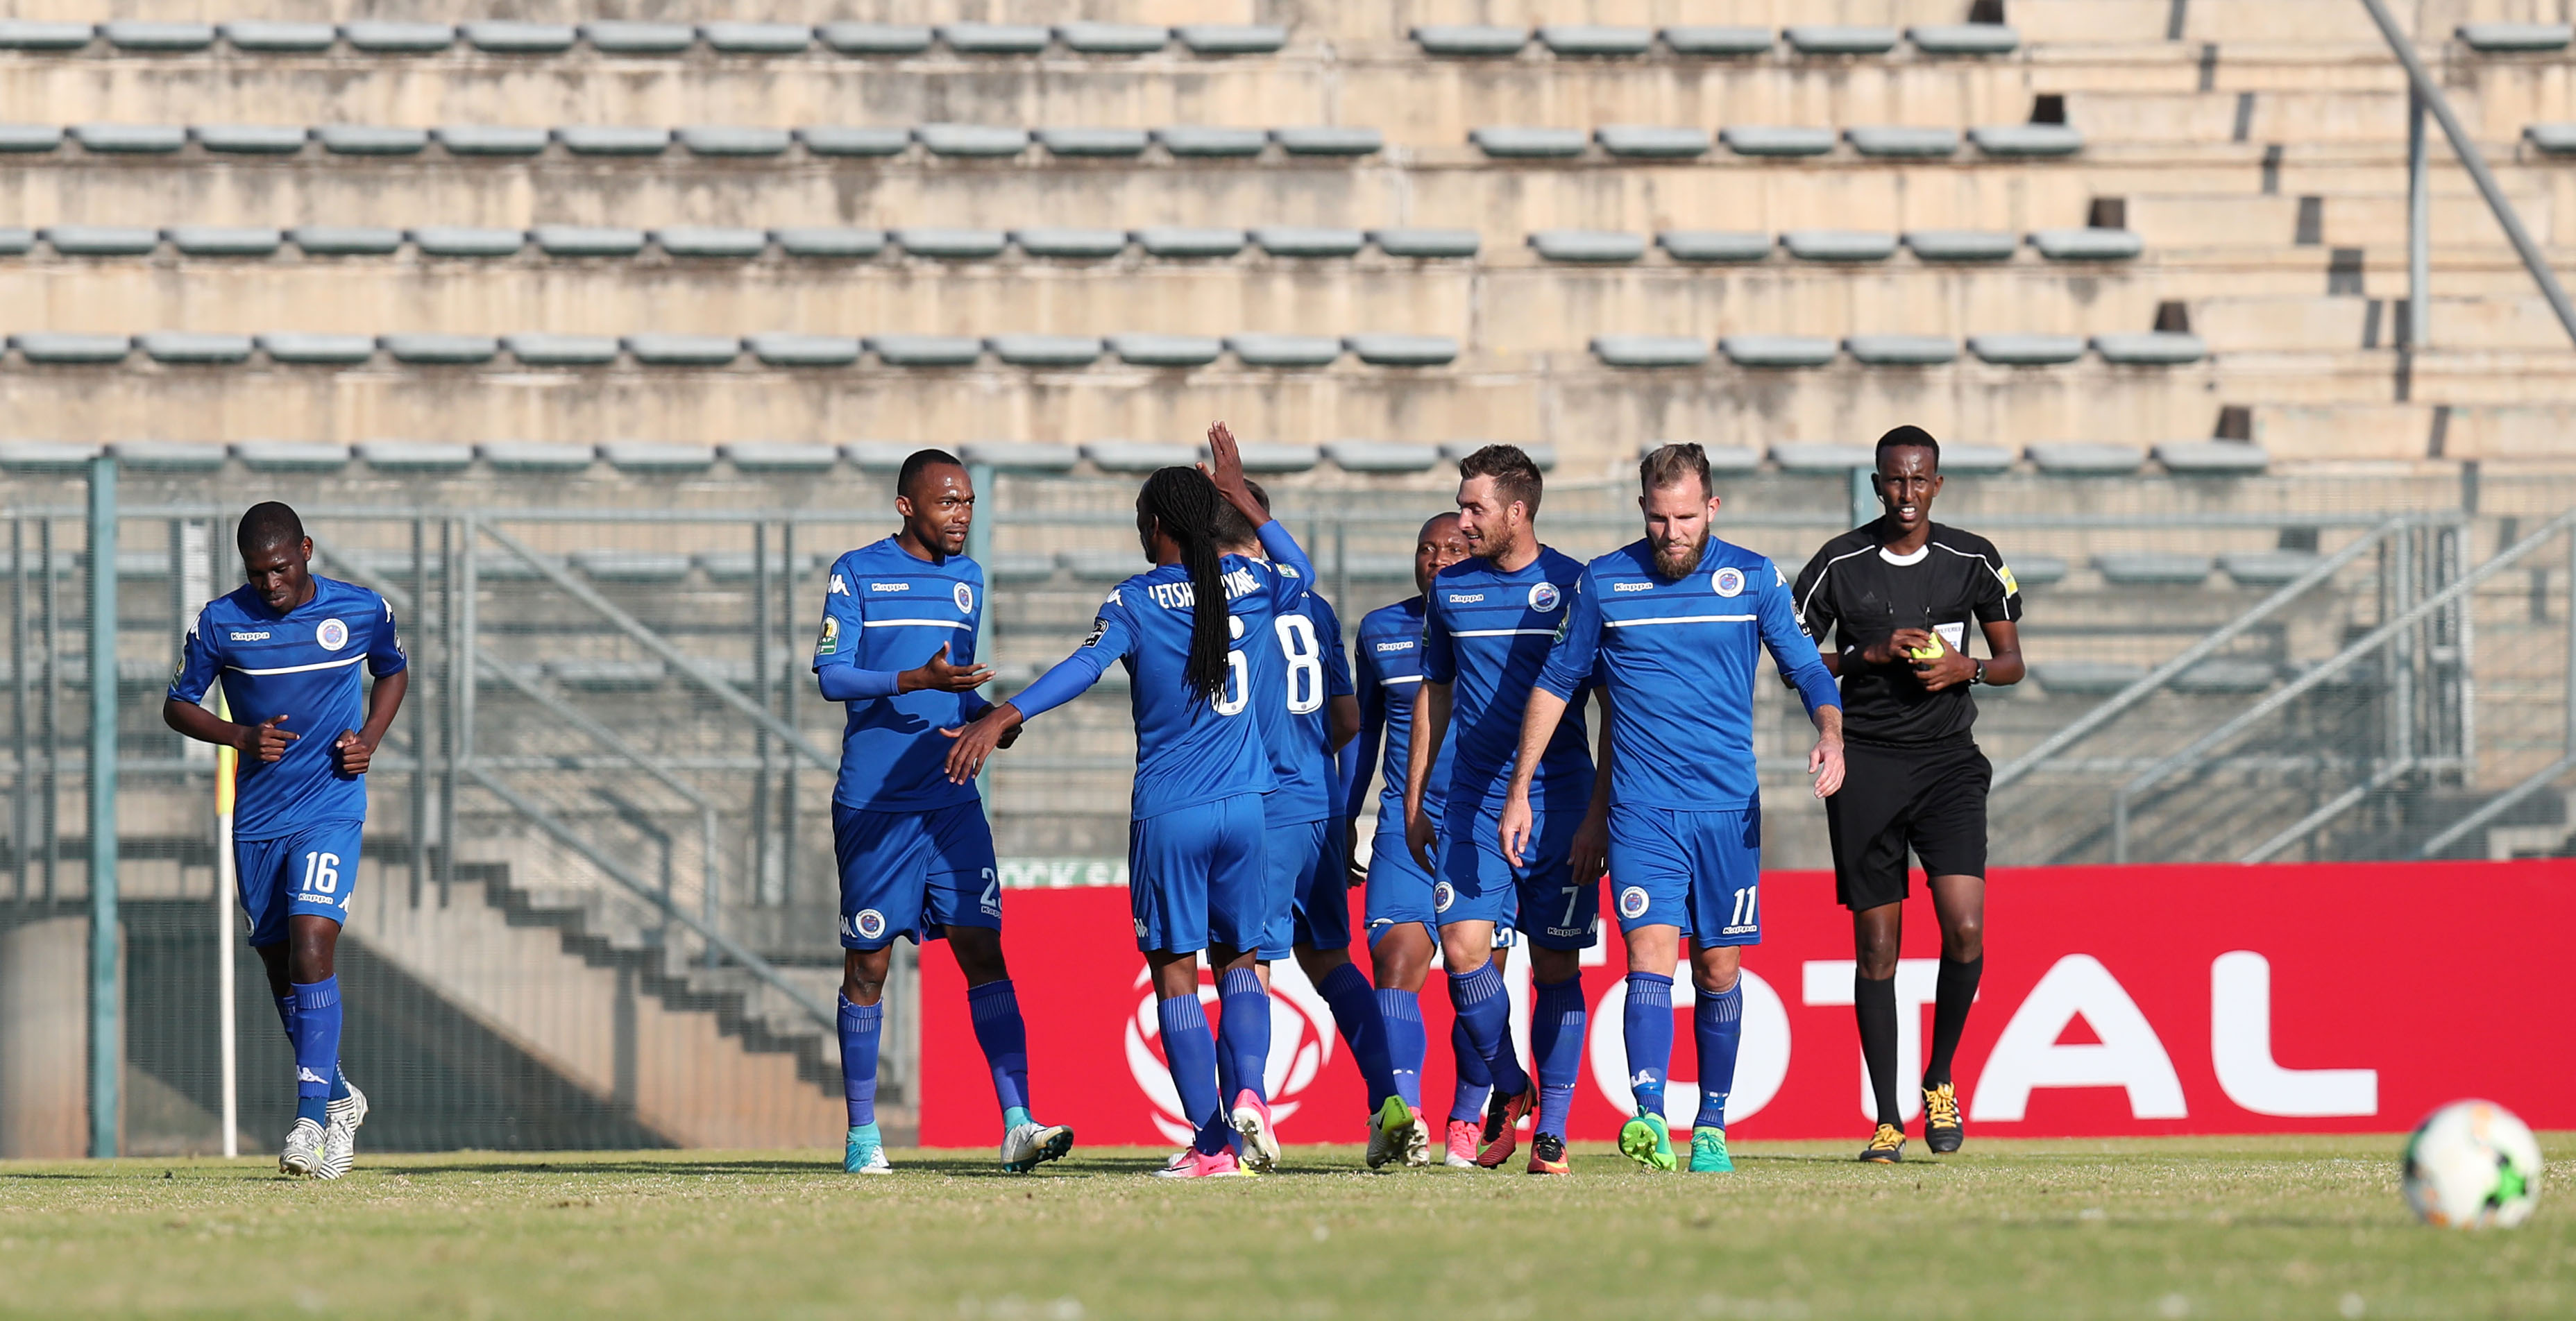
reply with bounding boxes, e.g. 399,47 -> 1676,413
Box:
1610,803 -> 1762,948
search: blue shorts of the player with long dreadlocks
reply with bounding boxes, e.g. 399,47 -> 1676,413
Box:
1128,793 -> 1270,953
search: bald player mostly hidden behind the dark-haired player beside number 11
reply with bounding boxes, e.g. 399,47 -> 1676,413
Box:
1345,513 -> 1512,1169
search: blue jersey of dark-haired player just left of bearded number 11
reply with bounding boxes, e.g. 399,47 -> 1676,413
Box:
1422,546 -> 1592,811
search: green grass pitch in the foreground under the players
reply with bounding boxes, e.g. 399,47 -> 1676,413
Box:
0,1133 -> 2576,1321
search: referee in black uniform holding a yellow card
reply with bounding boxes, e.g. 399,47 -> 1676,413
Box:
1793,427 -> 2022,1161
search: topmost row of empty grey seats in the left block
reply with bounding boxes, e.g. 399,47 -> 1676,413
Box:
0,18 -> 1288,57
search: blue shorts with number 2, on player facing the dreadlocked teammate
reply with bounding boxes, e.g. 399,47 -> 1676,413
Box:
832,803 -> 1002,951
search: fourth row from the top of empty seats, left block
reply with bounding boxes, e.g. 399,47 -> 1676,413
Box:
8,330 -> 1458,368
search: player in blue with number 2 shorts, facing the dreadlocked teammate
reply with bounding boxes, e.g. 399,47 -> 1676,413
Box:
814,451 -> 1074,1174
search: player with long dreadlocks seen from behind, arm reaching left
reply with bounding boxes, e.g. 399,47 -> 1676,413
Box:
948,423 -> 1314,1179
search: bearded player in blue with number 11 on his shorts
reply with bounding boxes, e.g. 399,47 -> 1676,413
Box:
1502,445 -> 1842,1172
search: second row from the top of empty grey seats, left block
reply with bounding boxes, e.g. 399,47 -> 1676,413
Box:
0,123 -> 1391,160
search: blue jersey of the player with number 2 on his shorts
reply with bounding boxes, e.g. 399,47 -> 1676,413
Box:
814,536 -> 987,811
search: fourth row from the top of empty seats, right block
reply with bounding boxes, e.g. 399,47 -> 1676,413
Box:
1592,330 -> 2210,368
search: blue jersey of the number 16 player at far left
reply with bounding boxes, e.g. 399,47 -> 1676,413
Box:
170,574 -> 409,840
